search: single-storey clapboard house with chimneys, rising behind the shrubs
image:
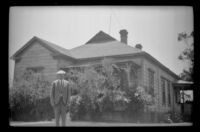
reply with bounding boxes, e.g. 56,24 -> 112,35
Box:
11,30 -> 184,112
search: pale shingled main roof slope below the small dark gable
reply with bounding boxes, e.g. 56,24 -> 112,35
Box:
70,41 -> 143,59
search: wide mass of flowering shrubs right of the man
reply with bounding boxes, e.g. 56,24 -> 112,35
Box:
70,60 -> 156,119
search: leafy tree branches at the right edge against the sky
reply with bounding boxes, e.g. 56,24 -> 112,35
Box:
178,31 -> 194,81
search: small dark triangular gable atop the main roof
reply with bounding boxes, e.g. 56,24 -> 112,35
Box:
86,31 -> 116,44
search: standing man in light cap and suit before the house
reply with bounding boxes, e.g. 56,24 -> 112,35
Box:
50,70 -> 71,126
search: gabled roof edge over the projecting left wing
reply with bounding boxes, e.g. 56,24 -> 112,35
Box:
11,36 -> 71,60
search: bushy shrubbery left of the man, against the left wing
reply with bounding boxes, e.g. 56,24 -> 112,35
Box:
9,71 -> 53,120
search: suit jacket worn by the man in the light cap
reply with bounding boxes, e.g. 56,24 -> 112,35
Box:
50,79 -> 71,106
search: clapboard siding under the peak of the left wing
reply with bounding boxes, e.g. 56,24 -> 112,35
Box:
15,42 -> 57,82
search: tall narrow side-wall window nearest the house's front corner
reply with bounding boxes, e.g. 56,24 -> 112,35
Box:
148,69 -> 154,95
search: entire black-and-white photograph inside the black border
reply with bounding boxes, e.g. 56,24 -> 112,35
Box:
8,6 -> 194,127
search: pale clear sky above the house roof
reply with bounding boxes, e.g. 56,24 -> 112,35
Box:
8,6 -> 193,84
